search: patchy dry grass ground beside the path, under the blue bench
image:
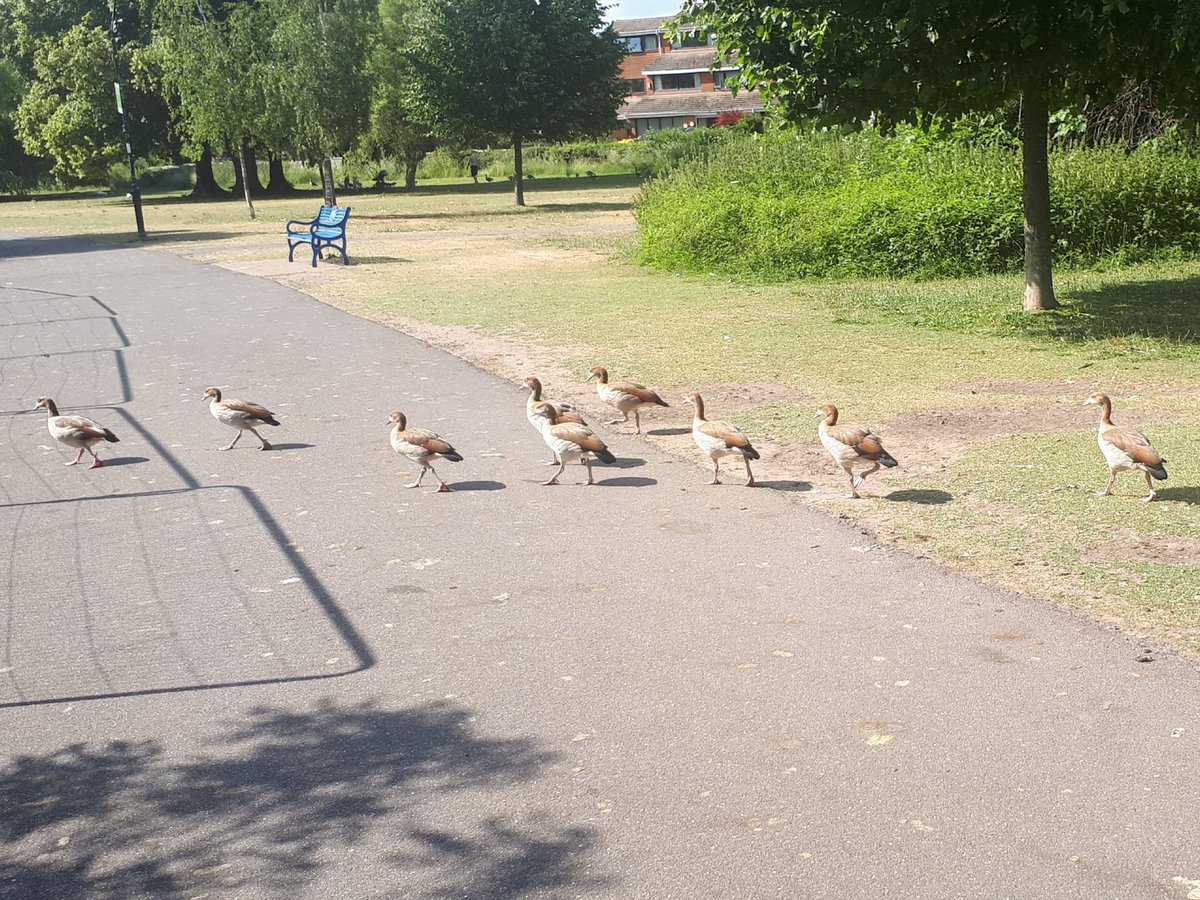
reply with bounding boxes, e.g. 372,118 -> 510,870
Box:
5,176 -> 1200,652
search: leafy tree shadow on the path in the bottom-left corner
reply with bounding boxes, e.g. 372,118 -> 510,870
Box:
0,702 -> 598,900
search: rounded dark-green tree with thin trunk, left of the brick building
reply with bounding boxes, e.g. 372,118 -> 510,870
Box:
409,0 -> 625,205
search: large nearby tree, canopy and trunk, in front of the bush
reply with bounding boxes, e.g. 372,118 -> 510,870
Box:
684,0 -> 1196,308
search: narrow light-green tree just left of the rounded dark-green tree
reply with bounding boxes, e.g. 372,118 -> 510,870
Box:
364,0 -> 438,190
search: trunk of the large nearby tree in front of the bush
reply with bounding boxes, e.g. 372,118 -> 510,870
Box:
1021,79 -> 1058,311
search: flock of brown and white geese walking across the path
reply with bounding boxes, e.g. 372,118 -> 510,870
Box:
35,366 -> 1166,502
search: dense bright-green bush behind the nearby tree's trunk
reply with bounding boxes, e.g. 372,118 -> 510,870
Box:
636,130 -> 1200,280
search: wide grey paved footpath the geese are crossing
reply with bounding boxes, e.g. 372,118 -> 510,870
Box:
0,239 -> 1200,900
